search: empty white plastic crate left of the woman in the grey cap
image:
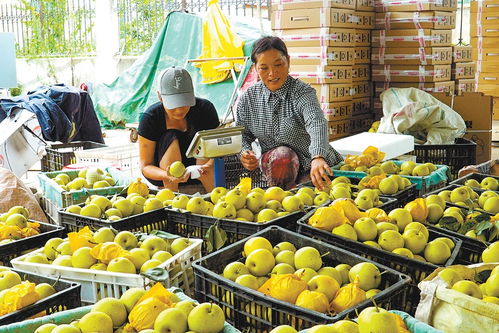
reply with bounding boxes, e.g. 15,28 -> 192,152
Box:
74,143 -> 142,177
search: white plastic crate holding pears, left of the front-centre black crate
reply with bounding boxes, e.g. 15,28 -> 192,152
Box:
11,239 -> 203,304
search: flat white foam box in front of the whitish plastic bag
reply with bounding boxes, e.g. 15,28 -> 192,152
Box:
330,132 -> 414,160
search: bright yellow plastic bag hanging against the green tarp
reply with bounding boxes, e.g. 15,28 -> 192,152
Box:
194,0 -> 244,84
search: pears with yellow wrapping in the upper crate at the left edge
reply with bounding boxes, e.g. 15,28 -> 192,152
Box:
0,206 -> 40,245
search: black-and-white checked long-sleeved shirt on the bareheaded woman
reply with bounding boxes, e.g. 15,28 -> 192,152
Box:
236,76 -> 342,173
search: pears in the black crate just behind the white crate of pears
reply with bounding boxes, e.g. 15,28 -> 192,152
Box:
65,189 -> 175,221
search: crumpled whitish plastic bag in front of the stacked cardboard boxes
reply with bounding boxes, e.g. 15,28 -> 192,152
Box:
378,88 -> 466,145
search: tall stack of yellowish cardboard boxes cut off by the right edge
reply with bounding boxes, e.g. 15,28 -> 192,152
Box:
470,0 -> 499,120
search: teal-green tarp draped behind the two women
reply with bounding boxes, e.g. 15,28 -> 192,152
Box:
90,12 -> 266,128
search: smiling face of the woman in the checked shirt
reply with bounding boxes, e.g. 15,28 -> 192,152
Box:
255,49 -> 289,91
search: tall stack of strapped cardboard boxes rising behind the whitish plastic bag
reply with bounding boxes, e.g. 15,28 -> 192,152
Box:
371,0 -> 457,118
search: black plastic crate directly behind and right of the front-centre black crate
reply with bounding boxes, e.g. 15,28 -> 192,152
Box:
298,210 -> 462,314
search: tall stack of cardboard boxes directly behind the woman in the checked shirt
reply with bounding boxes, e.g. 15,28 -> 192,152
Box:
272,0 -> 374,139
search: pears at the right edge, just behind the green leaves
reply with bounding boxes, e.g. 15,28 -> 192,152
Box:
438,184 -> 499,215
